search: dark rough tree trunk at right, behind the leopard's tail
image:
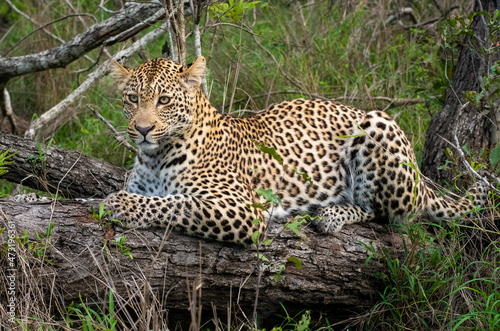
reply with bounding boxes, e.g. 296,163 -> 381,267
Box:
421,0 -> 498,187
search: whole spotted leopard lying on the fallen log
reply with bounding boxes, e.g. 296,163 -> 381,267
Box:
105,57 -> 485,245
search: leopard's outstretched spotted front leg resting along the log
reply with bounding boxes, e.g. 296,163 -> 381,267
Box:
104,191 -> 265,244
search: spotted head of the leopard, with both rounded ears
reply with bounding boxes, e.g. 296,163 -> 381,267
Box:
111,56 -> 205,150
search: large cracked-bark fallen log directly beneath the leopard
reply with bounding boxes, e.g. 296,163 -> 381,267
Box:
0,200 -> 403,319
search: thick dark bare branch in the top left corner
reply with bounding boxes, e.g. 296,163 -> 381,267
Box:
0,2 -> 163,86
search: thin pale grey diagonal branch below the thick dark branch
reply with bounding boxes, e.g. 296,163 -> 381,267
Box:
24,23 -> 170,139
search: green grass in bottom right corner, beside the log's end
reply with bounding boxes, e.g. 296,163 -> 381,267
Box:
359,223 -> 500,330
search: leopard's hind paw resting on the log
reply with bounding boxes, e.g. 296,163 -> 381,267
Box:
313,204 -> 375,234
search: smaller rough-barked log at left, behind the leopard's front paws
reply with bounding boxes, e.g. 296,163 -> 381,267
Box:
0,131 -> 127,198
